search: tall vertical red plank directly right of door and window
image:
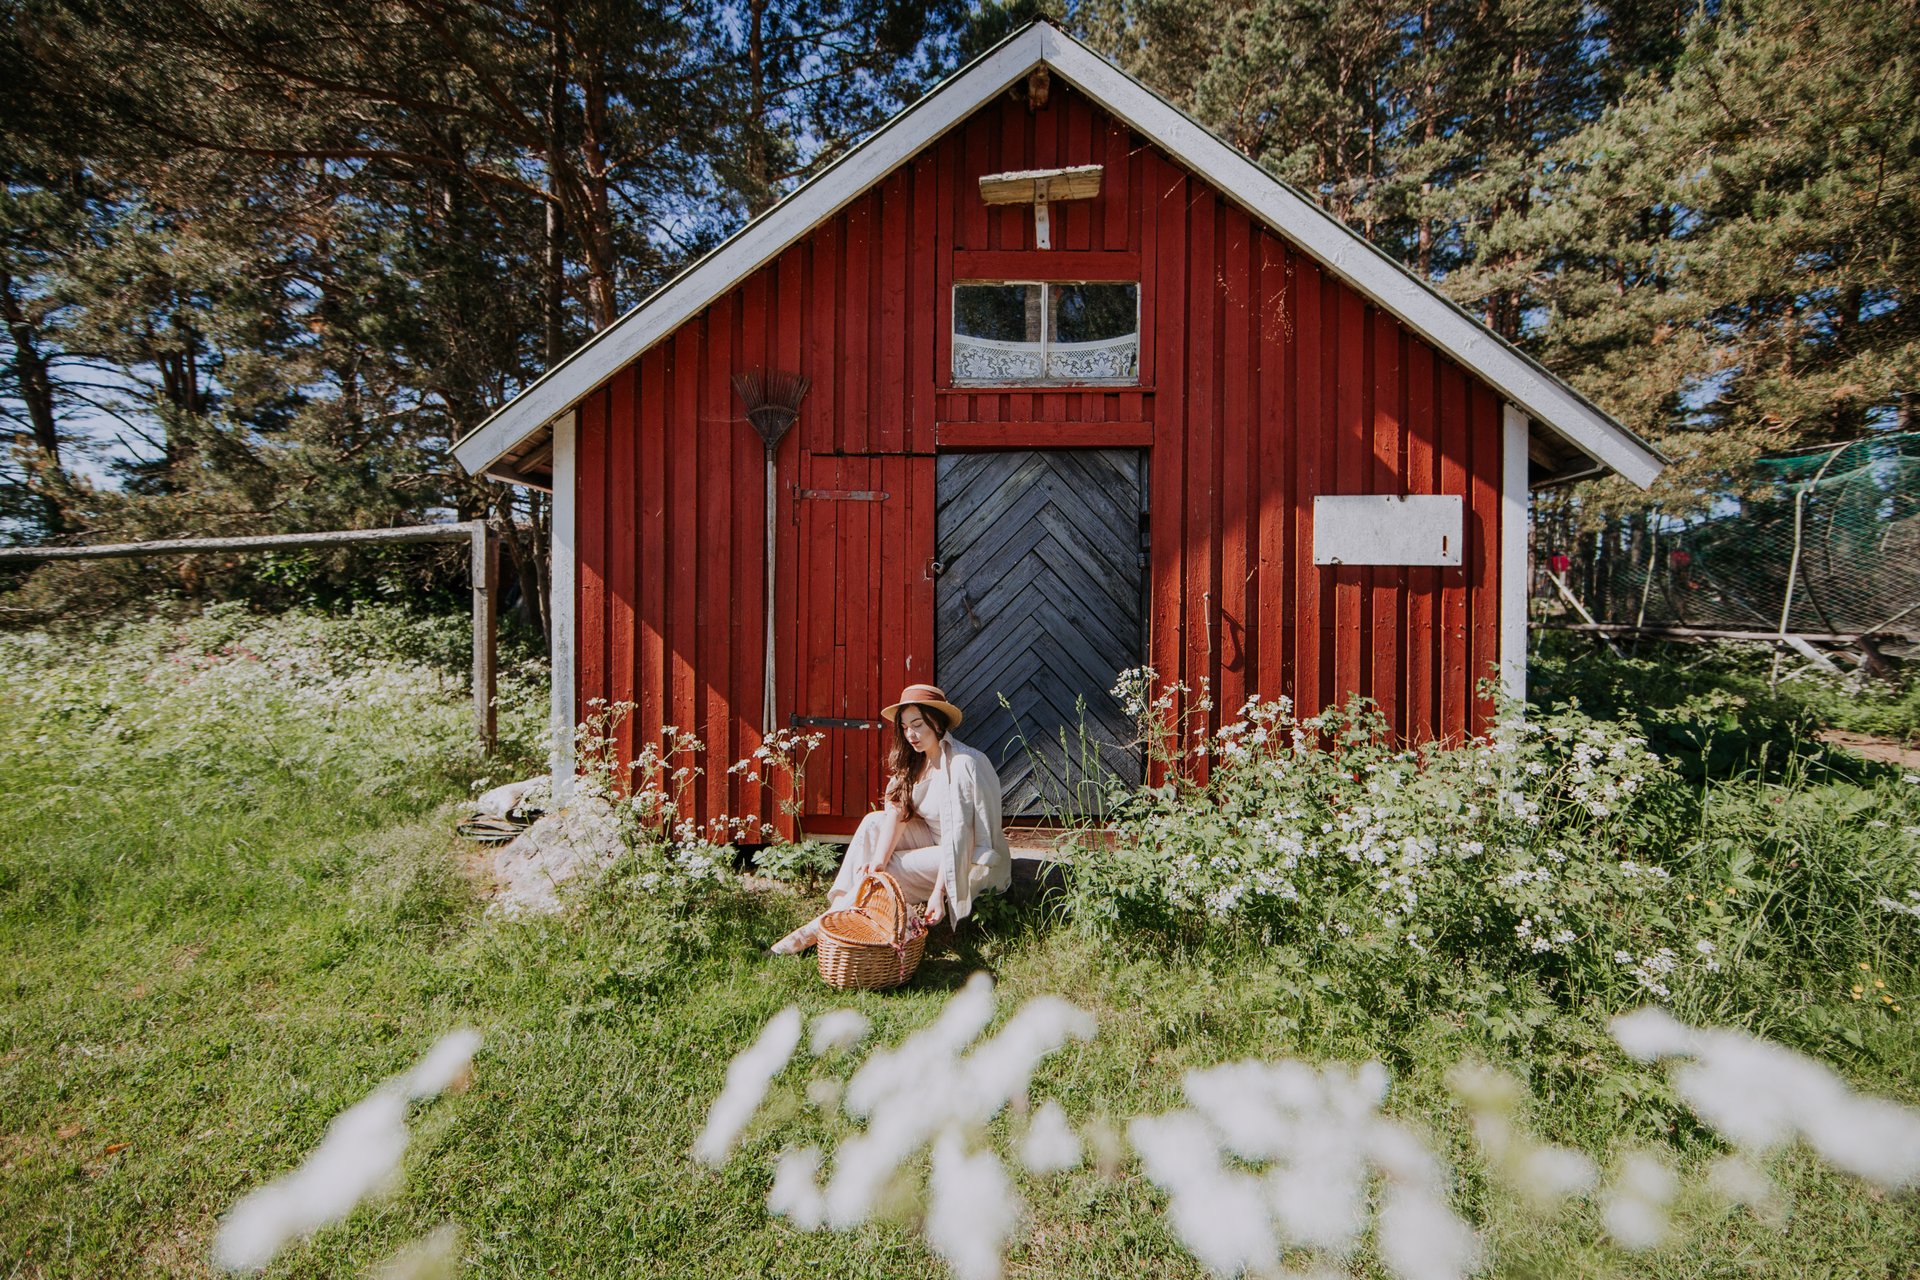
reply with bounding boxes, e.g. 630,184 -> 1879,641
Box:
1142,160 -> 1198,759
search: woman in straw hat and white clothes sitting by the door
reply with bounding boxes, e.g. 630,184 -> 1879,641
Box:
774,685 -> 1014,956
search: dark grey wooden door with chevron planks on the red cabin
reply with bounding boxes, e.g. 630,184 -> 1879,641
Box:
933,449 -> 1146,816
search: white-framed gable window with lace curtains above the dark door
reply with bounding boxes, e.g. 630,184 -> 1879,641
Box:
954,282 -> 1140,386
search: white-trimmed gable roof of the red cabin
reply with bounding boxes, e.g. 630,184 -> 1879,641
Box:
453,21 -> 1665,487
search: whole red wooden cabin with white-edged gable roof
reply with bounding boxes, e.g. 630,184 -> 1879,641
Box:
455,23 -> 1661,831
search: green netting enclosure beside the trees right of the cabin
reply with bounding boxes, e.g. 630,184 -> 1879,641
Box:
1546,432 -> 1920,639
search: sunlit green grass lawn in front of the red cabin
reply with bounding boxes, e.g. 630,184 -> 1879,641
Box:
0,616 -> 1920,1278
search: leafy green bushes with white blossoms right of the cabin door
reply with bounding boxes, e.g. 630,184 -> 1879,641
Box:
1066,664 -> 1920,1042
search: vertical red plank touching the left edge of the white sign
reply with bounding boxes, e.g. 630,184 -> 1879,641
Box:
1286,251 -> 1327,718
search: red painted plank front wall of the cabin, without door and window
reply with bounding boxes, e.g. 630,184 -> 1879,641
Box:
576,81 -> 1501,831
